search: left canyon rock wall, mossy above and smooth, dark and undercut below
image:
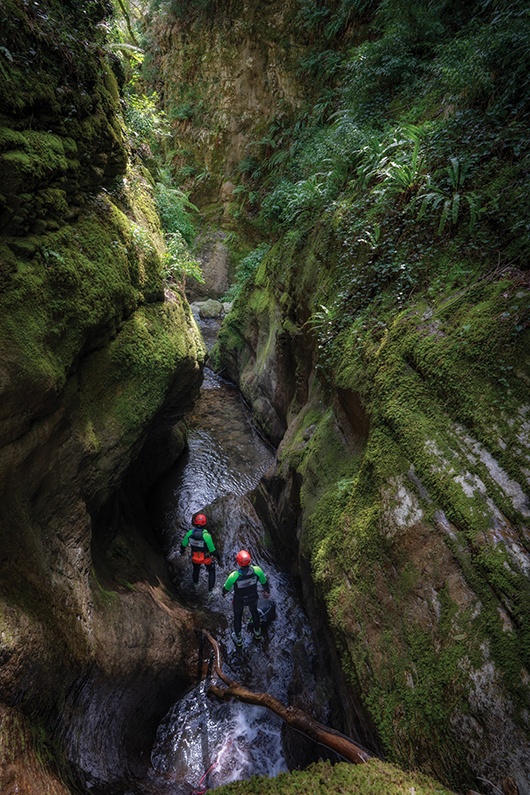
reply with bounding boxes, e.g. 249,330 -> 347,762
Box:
0,0 -> 204,795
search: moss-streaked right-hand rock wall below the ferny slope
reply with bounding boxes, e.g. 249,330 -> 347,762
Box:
214,235 -> 530,793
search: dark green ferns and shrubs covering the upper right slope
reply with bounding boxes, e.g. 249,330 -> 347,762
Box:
232,2 -> 530,268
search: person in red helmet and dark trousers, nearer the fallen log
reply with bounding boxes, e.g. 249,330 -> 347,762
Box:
222,549 -> 270,646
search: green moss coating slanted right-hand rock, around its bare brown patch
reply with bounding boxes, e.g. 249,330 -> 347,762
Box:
309,283 -> 530,778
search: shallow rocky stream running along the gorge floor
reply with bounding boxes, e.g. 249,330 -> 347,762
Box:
141,320 -> 327,795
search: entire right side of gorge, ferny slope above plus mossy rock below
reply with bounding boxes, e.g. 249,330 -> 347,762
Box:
164,0 -> 530,789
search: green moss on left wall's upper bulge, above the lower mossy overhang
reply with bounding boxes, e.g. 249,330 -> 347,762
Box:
0,162 -> 173,388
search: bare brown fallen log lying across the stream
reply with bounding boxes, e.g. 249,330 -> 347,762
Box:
203,630 -> 372,765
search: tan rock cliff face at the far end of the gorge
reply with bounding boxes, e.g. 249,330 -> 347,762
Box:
146,0 -> 307,208
